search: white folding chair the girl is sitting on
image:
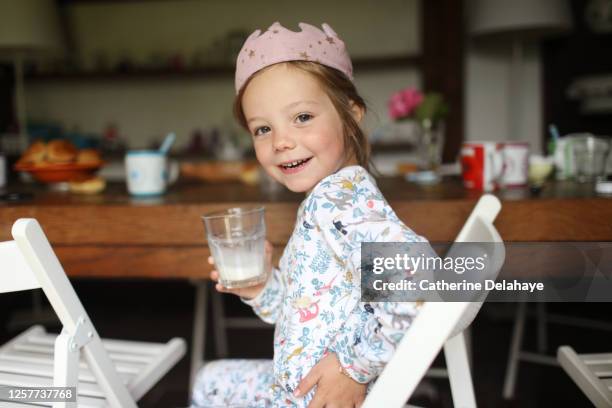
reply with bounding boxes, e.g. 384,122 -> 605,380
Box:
363,195 -> 505,408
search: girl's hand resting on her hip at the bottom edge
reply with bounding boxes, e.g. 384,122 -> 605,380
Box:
294,353 -> 367,408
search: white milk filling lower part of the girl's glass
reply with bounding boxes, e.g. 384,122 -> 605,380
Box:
208,234 -> 265,288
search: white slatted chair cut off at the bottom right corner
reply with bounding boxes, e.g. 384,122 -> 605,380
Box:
557,346 -> 612,408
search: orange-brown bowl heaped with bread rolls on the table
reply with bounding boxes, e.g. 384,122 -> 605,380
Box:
15,139 -> 104,183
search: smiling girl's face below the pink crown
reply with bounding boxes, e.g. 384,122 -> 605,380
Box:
242,64 -> 355,192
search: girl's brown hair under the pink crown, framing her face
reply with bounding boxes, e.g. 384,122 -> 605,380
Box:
234,61 -> 370,169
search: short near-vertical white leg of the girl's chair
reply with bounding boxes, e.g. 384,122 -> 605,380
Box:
444,333 -> 476,408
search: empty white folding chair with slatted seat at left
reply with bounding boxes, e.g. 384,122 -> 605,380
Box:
0,219 -> 186,408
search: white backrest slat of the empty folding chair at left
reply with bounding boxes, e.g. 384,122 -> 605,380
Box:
0,241 -> 40,293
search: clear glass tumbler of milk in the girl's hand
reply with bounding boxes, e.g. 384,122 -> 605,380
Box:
202,207 -> 266,288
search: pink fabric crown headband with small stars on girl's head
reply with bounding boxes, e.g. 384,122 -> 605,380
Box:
235,22 -> 353,93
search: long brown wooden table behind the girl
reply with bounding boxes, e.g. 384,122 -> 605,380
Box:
0,177 -> 612,279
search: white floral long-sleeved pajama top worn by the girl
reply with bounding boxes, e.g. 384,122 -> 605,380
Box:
245,166 -> 426,406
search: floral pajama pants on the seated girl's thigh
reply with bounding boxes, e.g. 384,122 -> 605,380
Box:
191,360 -> 274,408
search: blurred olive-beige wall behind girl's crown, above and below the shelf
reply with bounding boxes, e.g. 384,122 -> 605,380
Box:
26,0 -> 421,150
